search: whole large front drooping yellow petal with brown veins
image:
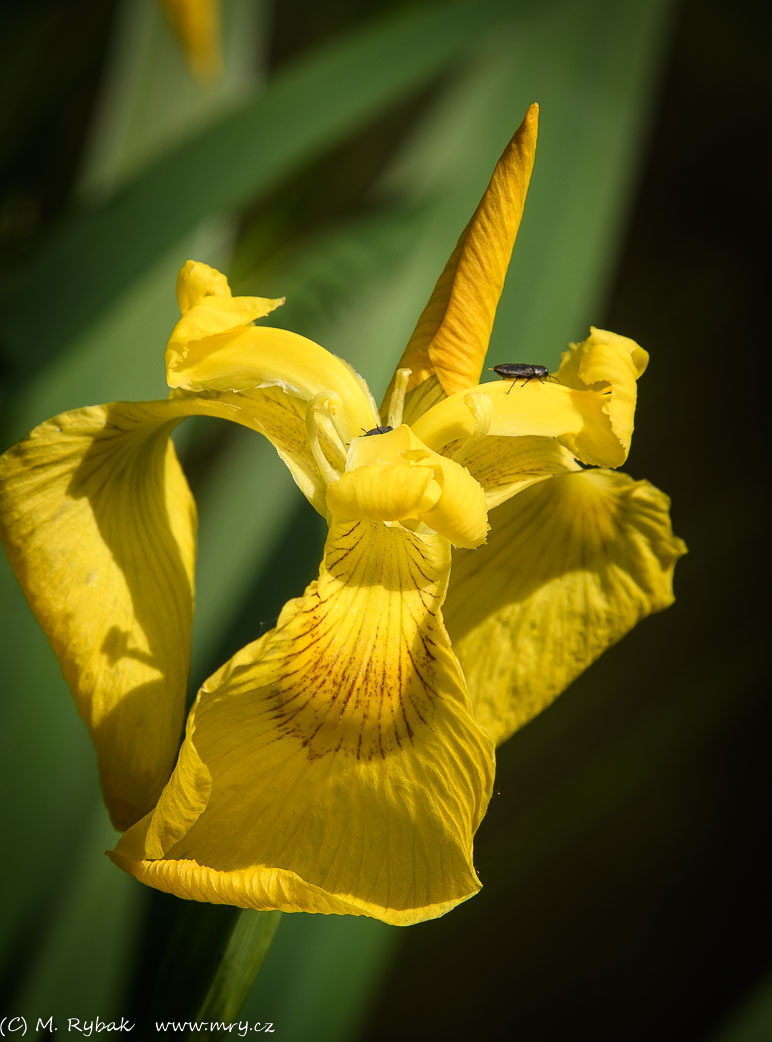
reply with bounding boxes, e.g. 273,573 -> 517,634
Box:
111,522 -> 494,925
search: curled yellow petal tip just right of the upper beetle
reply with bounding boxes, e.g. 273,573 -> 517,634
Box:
556,327 -> 649,467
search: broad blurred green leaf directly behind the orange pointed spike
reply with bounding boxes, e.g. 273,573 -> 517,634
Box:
234,0 -> 673,397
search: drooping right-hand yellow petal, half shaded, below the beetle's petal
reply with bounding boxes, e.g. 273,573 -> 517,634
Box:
445,470 -> 686,743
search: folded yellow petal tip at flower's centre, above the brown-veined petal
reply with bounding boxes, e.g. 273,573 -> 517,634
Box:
327,424 -> 488,547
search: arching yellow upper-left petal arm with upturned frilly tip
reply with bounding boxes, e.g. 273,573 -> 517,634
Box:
167,261 -> 379,441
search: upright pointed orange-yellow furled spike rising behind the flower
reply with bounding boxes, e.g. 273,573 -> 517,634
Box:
384,105 -> 539,414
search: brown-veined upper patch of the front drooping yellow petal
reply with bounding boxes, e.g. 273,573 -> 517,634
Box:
264,522 -> 452,761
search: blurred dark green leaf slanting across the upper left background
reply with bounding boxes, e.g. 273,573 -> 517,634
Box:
4,0 -> 509,383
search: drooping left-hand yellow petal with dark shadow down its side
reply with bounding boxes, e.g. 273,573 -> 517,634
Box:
0,402 -> 196,827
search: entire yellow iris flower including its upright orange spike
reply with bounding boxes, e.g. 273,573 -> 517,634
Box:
0,106 -> 683,925
